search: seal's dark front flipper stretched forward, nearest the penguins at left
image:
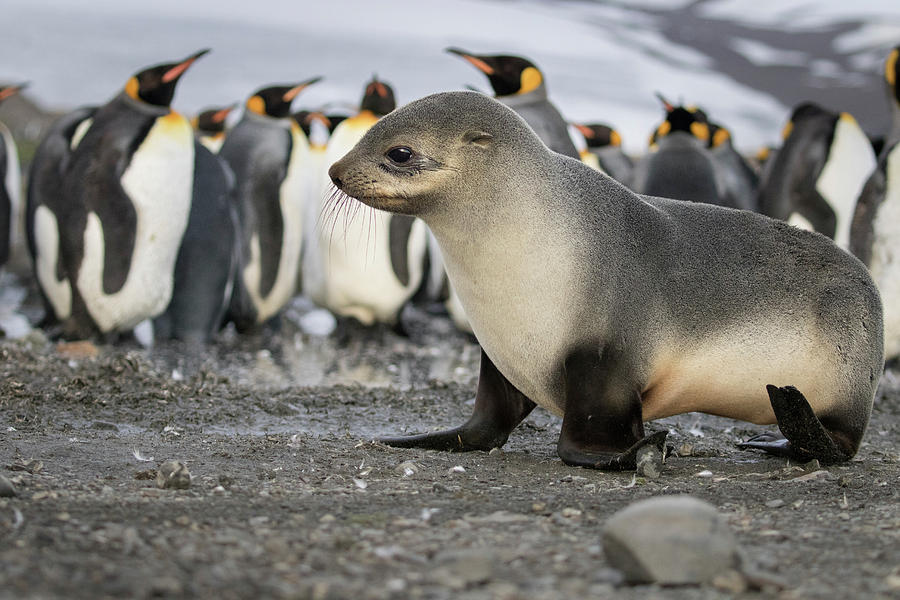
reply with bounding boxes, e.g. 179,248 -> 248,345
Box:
378,350 -> 535,452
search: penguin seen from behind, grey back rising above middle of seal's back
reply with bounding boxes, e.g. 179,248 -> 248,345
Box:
631,96 -> 734,208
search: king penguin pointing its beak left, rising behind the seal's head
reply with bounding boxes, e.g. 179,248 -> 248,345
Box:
447,48 -> 581,159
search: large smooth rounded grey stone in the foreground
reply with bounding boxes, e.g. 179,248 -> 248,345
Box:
603,496 -> 741,585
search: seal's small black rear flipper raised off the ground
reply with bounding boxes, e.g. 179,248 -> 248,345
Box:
738,385 -> 851,464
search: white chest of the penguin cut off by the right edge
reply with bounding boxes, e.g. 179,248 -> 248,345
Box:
869,145 -> 900,358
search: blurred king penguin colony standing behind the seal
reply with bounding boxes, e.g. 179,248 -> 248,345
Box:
0,46 -> 900,358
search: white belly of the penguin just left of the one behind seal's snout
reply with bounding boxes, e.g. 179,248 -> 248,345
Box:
243,127 -> 309,323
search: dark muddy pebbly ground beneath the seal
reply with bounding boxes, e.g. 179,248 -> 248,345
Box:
0,296 -> 900,600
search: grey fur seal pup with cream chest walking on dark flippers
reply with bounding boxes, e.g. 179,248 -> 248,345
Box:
329,92 -> 883,469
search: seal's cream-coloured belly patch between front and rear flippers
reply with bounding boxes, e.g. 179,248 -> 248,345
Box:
642,321 -> 844,424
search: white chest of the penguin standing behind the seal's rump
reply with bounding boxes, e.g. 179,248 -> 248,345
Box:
816,113 -> 877,249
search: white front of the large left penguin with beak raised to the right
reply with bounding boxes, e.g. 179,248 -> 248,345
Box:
77,113 -> 194,332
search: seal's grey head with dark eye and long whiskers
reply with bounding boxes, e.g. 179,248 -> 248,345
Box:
328,92 -> 551,216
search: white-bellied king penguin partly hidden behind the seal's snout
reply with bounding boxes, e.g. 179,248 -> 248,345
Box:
303,77 -> 428,332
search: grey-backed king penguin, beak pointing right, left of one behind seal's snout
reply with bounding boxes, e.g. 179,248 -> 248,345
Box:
219,77 -> 321,332
